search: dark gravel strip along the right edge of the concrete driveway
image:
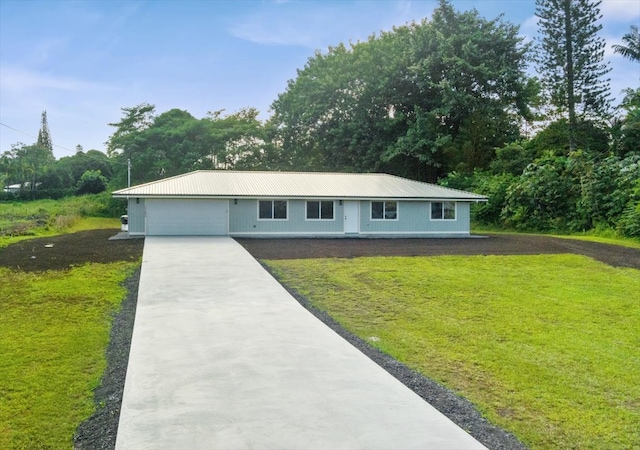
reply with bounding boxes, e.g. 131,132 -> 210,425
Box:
260,262 -> 527,450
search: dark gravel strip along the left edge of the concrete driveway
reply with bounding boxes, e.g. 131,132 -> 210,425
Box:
73,267 -> 140,450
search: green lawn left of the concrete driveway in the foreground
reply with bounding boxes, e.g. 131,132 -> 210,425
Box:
0,263 -> 137,449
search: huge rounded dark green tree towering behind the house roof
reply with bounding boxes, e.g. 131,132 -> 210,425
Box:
272,1 -> 536,180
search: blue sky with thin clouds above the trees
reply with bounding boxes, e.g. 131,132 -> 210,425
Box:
0,0 -> 640,158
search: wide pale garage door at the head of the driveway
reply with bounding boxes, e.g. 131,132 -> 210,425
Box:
145,199 -> 229,236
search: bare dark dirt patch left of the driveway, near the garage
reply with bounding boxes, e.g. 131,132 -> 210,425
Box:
0,229 -> 144,272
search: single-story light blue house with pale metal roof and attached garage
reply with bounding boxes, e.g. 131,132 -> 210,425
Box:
113,170 -> 487,237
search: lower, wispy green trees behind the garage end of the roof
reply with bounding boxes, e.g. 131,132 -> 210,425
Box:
107,104 -> 270,188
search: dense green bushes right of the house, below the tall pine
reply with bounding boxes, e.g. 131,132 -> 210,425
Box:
502,152 -> 640,236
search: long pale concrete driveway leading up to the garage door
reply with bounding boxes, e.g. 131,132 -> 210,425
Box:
116,237 -> 484,450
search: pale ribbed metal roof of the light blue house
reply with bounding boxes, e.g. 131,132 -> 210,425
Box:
113,170 -> 487,201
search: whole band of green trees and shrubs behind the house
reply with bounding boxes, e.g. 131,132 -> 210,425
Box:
0,0 -> 640,235
